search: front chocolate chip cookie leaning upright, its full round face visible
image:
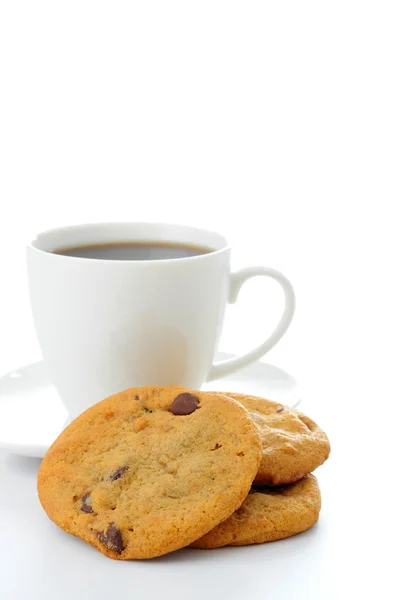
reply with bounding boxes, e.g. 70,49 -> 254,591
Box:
38,386 -> 261,560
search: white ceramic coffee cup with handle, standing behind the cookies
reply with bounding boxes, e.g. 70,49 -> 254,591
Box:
27,223 -> 295,417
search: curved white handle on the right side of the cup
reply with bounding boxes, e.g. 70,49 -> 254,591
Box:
207,267 -> 296,381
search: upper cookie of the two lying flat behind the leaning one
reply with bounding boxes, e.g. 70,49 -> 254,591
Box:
221,392 -> 330,485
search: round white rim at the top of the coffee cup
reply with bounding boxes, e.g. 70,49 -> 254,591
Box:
27,221 -> 230,266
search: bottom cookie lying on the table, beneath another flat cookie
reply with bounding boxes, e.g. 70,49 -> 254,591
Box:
191,475 -> 321,548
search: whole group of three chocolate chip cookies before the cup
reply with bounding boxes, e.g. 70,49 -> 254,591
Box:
38,386 -> 330,560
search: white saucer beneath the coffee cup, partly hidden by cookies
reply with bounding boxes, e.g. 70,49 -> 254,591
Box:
0,353 -> 300,458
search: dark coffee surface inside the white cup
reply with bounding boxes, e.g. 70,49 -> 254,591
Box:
53,242 -> 213,260
